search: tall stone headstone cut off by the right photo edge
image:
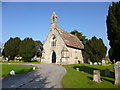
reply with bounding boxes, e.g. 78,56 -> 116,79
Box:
114,61 -> 120,85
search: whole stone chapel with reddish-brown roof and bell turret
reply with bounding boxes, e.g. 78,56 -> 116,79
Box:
41,12 -> 84,64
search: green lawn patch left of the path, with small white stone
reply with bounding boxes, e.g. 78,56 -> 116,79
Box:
0,64 -> 38,76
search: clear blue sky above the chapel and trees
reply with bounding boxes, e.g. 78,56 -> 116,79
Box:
2,2 -> 111,54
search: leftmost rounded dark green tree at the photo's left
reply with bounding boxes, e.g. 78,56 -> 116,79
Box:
2,37 -> 21,60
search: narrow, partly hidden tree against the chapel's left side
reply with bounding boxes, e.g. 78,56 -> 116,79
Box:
35,41 -> 43,57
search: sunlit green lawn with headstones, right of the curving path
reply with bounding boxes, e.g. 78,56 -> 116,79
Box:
62,64 -> 120,88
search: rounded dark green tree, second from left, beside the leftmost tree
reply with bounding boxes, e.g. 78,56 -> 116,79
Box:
19,38 -> 36,61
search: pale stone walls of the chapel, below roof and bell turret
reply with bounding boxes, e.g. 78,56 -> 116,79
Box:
41,30 -> 84,64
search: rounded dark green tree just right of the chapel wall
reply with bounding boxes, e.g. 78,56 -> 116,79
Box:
85,36 -> 107,62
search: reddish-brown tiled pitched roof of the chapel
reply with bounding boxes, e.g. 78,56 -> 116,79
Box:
56,28 -> 84,49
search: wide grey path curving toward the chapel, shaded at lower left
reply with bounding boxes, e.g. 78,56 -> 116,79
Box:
2,64 -> 66,88
